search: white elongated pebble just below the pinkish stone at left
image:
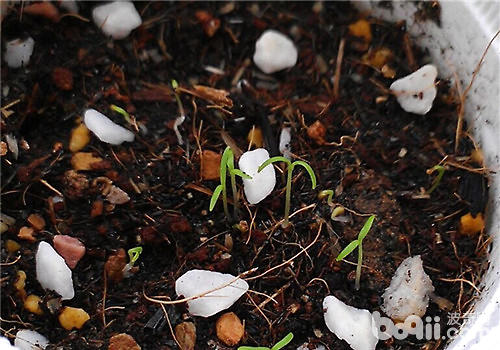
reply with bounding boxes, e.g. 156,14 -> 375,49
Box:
36,242 -> 75,300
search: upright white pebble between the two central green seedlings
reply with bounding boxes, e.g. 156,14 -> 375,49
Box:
238,148 -> 276,204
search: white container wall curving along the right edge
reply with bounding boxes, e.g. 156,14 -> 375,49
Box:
355,0 -> 500,350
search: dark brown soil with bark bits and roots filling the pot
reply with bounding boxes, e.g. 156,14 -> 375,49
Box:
1,2 -> 489,349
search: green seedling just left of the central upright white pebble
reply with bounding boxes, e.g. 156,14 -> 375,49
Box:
209,146 -> 252,218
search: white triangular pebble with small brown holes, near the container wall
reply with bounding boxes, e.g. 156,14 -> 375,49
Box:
390,64 -> 437,115
